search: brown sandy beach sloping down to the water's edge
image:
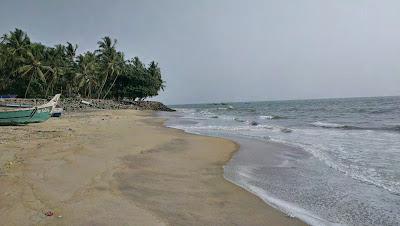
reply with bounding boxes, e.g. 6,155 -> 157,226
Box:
0,110 -> 304,225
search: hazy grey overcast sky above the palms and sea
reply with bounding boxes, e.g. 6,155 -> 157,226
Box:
0,0 -> 400,104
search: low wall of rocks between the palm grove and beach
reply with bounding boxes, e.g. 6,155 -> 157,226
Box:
0,98 -> 175,112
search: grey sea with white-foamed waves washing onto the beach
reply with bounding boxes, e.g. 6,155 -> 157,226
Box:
162,97 -> 400,225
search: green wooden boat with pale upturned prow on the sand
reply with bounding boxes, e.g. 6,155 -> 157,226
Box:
0,94 -> 61,125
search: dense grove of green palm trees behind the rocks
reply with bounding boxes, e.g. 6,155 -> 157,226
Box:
0,29 -> 165,100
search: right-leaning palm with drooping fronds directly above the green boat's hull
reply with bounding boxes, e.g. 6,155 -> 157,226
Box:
18,47 -> 53,98
